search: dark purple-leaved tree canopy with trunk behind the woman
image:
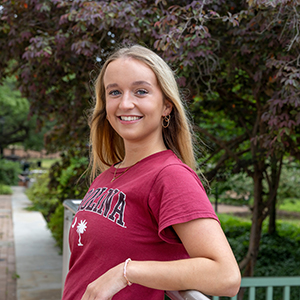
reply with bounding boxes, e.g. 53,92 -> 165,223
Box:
0,0 -> 300,275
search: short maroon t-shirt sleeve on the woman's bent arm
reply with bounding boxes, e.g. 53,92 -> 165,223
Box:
149,164 -> 219,244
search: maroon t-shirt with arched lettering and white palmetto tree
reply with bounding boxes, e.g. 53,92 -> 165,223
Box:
62,150 -> 218,300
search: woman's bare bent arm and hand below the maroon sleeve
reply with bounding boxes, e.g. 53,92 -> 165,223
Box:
82,219 -> 241,300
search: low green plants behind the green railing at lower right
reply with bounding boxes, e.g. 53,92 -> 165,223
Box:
218,214 -> 300,300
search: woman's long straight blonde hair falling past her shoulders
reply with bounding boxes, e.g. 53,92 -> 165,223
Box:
89,45 -> 196,179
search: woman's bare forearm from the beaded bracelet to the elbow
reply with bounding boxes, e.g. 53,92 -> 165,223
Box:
127,258 -> 240,296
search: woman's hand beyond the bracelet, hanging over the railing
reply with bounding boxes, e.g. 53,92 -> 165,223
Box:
81,263 -> 127,300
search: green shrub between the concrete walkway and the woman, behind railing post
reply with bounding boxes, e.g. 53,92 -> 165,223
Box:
26,152 -> 88,249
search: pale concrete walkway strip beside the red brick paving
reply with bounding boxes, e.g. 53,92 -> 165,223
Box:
11,187 -> 62,300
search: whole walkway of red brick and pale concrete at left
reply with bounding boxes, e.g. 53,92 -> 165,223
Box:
0,187 -> 62,300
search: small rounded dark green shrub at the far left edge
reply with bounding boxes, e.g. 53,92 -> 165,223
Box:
0,159 -> 22,185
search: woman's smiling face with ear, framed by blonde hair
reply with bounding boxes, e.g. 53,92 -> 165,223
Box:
103,58 -> 172,146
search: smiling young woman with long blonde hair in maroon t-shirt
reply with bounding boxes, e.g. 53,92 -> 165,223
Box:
63,46 -> 240,300
